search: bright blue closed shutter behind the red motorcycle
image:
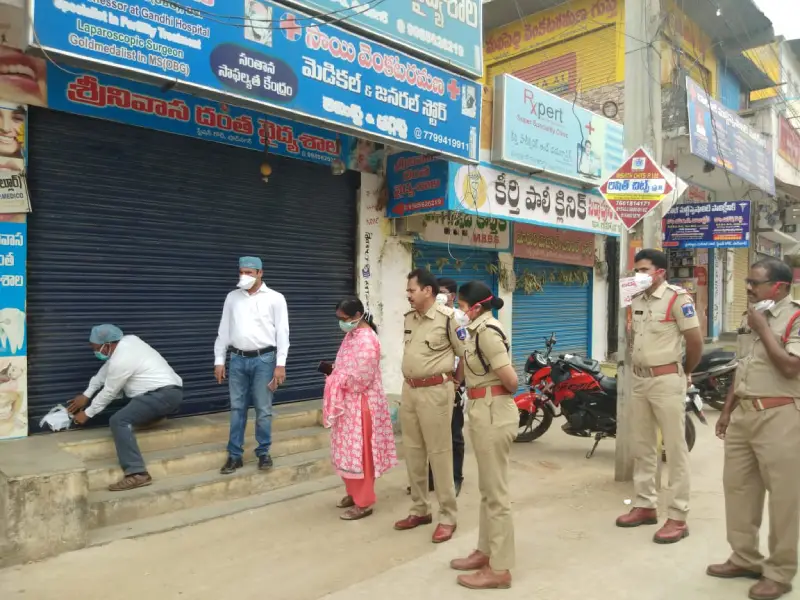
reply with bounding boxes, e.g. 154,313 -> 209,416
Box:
511,258 -> 592,385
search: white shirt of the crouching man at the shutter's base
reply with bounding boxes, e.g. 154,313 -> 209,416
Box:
83,335 -> 183,418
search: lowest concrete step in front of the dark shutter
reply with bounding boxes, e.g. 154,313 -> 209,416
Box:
89,448 -> 334,529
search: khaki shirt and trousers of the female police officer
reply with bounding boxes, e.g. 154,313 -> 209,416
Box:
464,313 -> 519,571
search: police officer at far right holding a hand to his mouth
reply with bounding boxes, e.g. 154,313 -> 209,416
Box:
706,258 -> 800,600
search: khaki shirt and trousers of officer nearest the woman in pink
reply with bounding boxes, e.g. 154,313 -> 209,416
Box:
399,304 -> 464,525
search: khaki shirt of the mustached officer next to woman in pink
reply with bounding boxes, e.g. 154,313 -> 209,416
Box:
402,304 -> 465,379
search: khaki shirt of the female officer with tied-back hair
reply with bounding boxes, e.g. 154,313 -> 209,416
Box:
464,312 -> 511,388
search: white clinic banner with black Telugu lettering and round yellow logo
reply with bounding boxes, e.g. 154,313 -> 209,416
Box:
448,164 -> 622,236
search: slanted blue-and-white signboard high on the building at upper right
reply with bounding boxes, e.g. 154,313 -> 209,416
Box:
686,76 -> 775,195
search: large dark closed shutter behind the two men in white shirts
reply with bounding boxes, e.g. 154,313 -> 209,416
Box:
28,108 -> 356,430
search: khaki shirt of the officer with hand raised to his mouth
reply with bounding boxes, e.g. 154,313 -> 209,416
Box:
734,297 -> 800,399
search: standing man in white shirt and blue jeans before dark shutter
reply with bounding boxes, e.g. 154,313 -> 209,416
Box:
214,256 -> 289,474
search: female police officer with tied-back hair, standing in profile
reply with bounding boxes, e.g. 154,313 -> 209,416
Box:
450,281 -> 519,590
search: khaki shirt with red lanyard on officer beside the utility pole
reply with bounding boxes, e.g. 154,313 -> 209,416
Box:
631,283 -> 700,367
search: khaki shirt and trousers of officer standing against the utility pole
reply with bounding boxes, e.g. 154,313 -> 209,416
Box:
631,283 -> 700,521
